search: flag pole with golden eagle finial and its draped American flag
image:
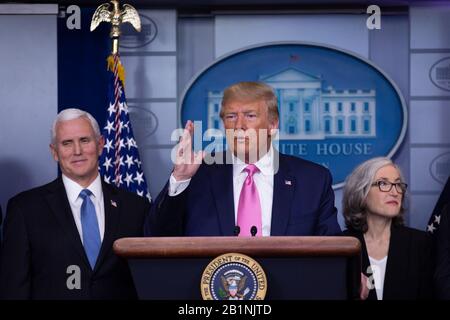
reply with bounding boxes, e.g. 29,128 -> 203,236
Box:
90,0 -> 151,200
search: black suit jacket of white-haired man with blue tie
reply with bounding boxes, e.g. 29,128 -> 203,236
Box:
0,178 -> 149,299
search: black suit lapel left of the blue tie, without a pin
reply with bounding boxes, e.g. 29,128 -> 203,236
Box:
46,178 -> 89,266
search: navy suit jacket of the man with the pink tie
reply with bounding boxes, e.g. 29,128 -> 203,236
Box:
146,154 -> 341,236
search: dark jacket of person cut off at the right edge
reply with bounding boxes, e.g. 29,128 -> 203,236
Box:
434,204 -> 450,300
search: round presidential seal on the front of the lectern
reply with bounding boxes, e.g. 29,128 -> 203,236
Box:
200,253 -> 267,300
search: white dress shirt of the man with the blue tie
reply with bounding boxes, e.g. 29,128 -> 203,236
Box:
62,175 -> 105,242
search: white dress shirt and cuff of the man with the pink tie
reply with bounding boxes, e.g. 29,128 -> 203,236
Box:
169,147 -> 274,236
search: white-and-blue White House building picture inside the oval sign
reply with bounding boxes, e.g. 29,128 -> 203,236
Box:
208,68 -> 376,140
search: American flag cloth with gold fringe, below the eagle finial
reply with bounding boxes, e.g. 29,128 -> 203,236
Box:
100,54 -> 151,201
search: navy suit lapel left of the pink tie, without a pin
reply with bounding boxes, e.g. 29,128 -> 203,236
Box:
208,156 -> 235,236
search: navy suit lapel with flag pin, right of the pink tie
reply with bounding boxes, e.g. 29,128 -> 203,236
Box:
270,154 -> 296,236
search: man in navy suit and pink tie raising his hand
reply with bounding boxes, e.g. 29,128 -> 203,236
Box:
146,82 -> 341,236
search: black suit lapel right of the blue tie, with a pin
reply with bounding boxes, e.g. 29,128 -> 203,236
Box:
94,181 -> 121,270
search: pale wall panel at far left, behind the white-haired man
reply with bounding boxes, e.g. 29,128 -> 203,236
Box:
0,5 -> 58,212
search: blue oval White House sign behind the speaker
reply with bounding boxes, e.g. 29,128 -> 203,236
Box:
181,43 -> 407,187
